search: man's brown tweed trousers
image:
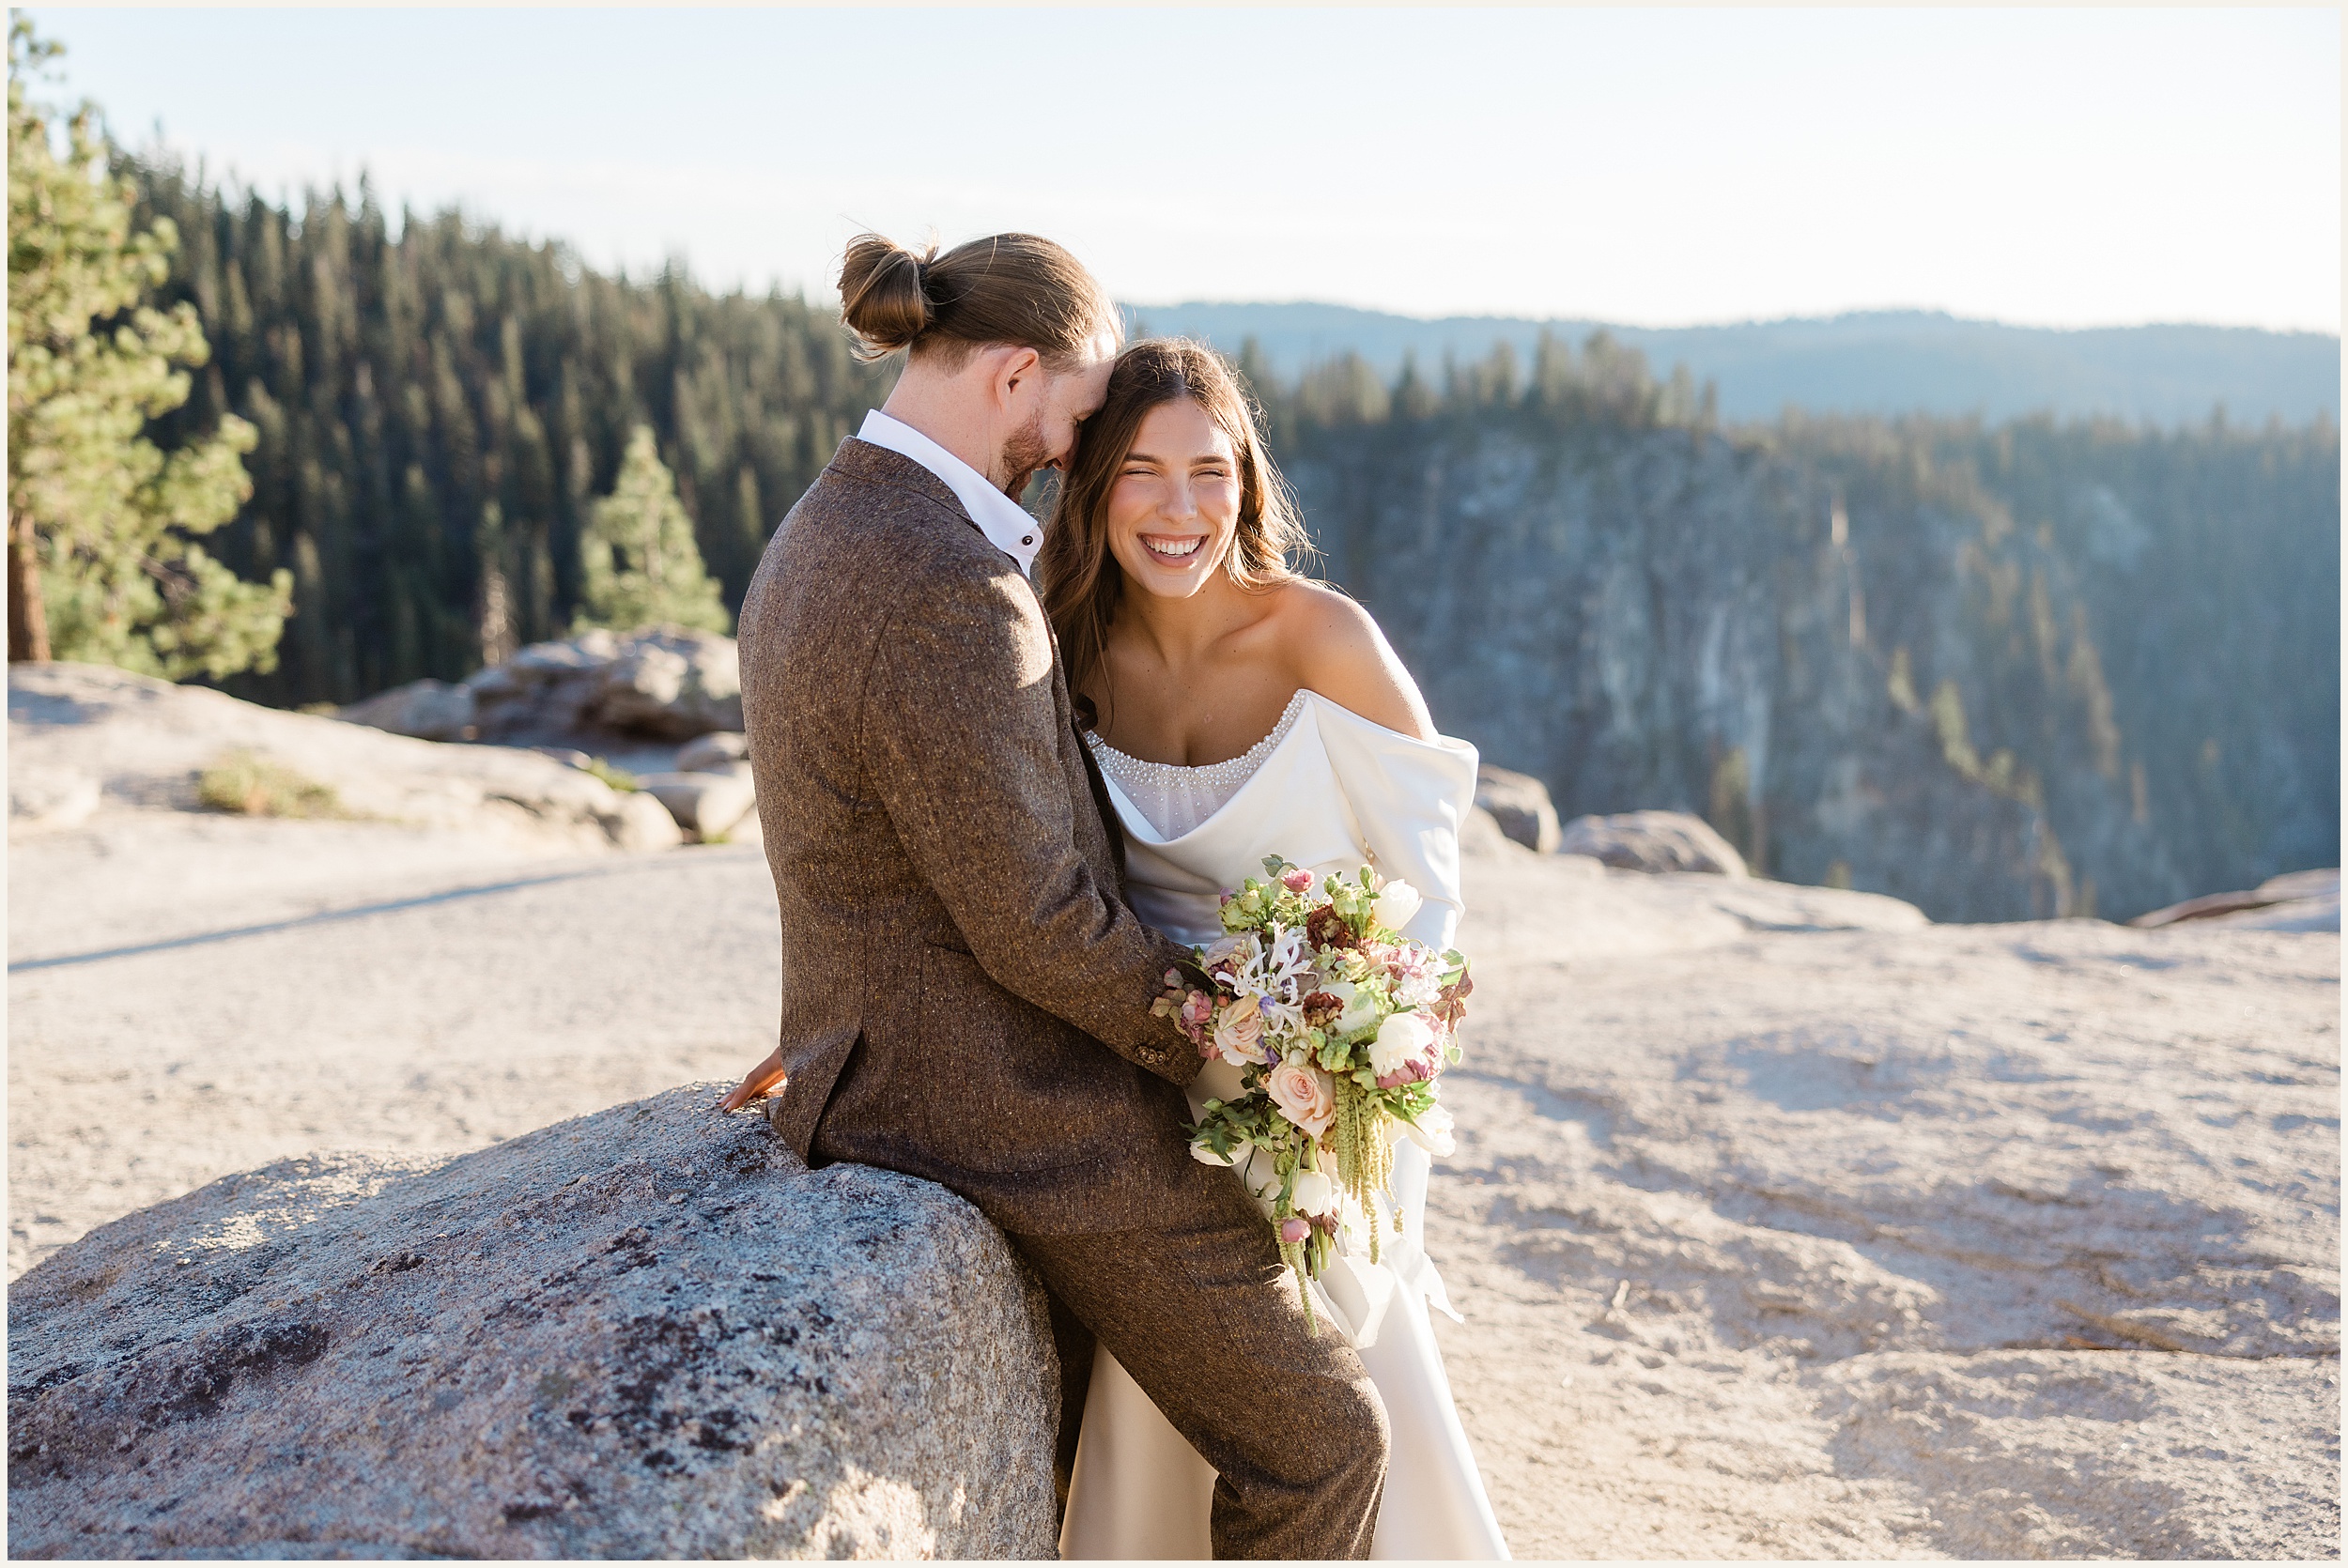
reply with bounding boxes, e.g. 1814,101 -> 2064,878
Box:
1012,1145 -> 1388,1559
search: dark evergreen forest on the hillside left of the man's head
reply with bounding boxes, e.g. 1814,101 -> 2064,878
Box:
120,160 -> 886,704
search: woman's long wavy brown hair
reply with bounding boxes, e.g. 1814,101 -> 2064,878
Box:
1036,338 -> 1313,726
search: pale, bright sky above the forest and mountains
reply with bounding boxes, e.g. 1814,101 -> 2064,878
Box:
33,8 -> 2341,331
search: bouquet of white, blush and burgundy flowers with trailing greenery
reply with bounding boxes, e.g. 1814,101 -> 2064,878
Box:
1155,854 -> 1470,1313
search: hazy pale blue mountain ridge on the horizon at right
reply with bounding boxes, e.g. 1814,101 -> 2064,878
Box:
1127,300 -> 2341,425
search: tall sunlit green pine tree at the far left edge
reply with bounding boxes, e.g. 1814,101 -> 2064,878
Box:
8,17 -> 291,681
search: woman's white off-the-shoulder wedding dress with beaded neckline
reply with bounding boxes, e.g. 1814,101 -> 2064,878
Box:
1059,690 -> 1507,1561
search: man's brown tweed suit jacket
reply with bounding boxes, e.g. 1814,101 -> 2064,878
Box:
742,439 -> 1200,1235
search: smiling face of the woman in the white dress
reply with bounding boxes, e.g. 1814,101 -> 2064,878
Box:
1108,397 -> 1240,599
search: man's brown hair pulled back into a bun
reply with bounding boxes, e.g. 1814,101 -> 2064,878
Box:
841,235 -> 1125,371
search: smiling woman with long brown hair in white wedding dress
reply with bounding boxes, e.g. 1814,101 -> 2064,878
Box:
1038,341 -> 1507,1559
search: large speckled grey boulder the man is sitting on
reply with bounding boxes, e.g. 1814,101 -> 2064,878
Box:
8,1084 -> 1059,1559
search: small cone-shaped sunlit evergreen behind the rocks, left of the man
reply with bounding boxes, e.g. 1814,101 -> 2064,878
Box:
578,425 -> 733,632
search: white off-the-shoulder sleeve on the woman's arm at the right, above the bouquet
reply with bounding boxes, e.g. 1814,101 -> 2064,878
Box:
1313,693 -> 1477,951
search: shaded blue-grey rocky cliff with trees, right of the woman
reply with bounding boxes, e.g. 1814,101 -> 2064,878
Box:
1282,407 -> 2339,920
